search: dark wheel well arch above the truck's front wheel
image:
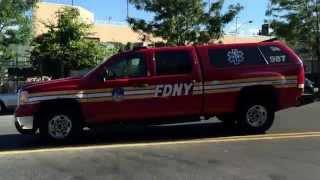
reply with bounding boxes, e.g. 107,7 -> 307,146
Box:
35,99 -> 84,128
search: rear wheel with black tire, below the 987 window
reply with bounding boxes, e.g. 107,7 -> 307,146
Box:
238,101 -> 275,133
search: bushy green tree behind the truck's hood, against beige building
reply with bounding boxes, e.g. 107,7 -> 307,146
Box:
31,7 -> 107,78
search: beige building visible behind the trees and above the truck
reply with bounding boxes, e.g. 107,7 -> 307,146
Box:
33,2 -> 269,44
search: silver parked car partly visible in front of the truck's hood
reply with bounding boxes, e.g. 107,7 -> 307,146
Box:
0,93 -> 18,113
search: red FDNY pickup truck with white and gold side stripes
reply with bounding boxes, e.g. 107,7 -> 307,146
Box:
15,41 -> 304,141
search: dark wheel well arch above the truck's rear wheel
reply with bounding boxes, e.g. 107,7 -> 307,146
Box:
237,85 -> 279,110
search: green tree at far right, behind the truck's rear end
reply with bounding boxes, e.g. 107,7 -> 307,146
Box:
266,0 -> 320,64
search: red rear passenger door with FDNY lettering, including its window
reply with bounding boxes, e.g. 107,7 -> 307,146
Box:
152,47 -> 202,117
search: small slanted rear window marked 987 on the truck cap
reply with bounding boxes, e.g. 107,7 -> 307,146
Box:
259,46 -> 290,64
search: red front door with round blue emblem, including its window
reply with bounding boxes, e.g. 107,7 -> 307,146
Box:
87,53 -> 153,123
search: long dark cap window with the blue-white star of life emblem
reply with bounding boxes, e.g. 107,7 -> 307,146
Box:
209,47 -> 266,68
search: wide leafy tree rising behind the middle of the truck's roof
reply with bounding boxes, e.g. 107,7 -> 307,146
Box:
128,0 -> 242,45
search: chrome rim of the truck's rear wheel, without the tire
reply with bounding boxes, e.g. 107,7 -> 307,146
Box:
246,105 -> 268,128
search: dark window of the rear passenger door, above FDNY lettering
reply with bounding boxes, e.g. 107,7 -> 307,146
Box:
155,51 -> 192,75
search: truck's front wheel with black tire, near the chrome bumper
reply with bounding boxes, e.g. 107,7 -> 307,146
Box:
40,111 -> 81,141
